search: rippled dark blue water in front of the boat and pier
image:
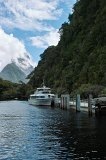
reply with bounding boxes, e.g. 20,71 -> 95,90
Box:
0,101 -> 106,160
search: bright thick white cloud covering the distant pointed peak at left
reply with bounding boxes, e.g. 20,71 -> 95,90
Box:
0,28 -> 35,71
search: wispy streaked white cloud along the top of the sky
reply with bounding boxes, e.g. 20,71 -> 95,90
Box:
0,0 -> 63,31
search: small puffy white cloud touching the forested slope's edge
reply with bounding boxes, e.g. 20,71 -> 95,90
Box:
30,30 -> 60,49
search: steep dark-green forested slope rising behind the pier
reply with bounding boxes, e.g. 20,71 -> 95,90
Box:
29,0 -> 106,96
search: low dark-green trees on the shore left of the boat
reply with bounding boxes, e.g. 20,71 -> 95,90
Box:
0,79 -> 32,100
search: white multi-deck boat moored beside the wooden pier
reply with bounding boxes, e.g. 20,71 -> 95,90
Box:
28,85 -> 55,106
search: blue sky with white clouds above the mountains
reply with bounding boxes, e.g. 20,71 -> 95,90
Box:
0,0 -> 76,68
